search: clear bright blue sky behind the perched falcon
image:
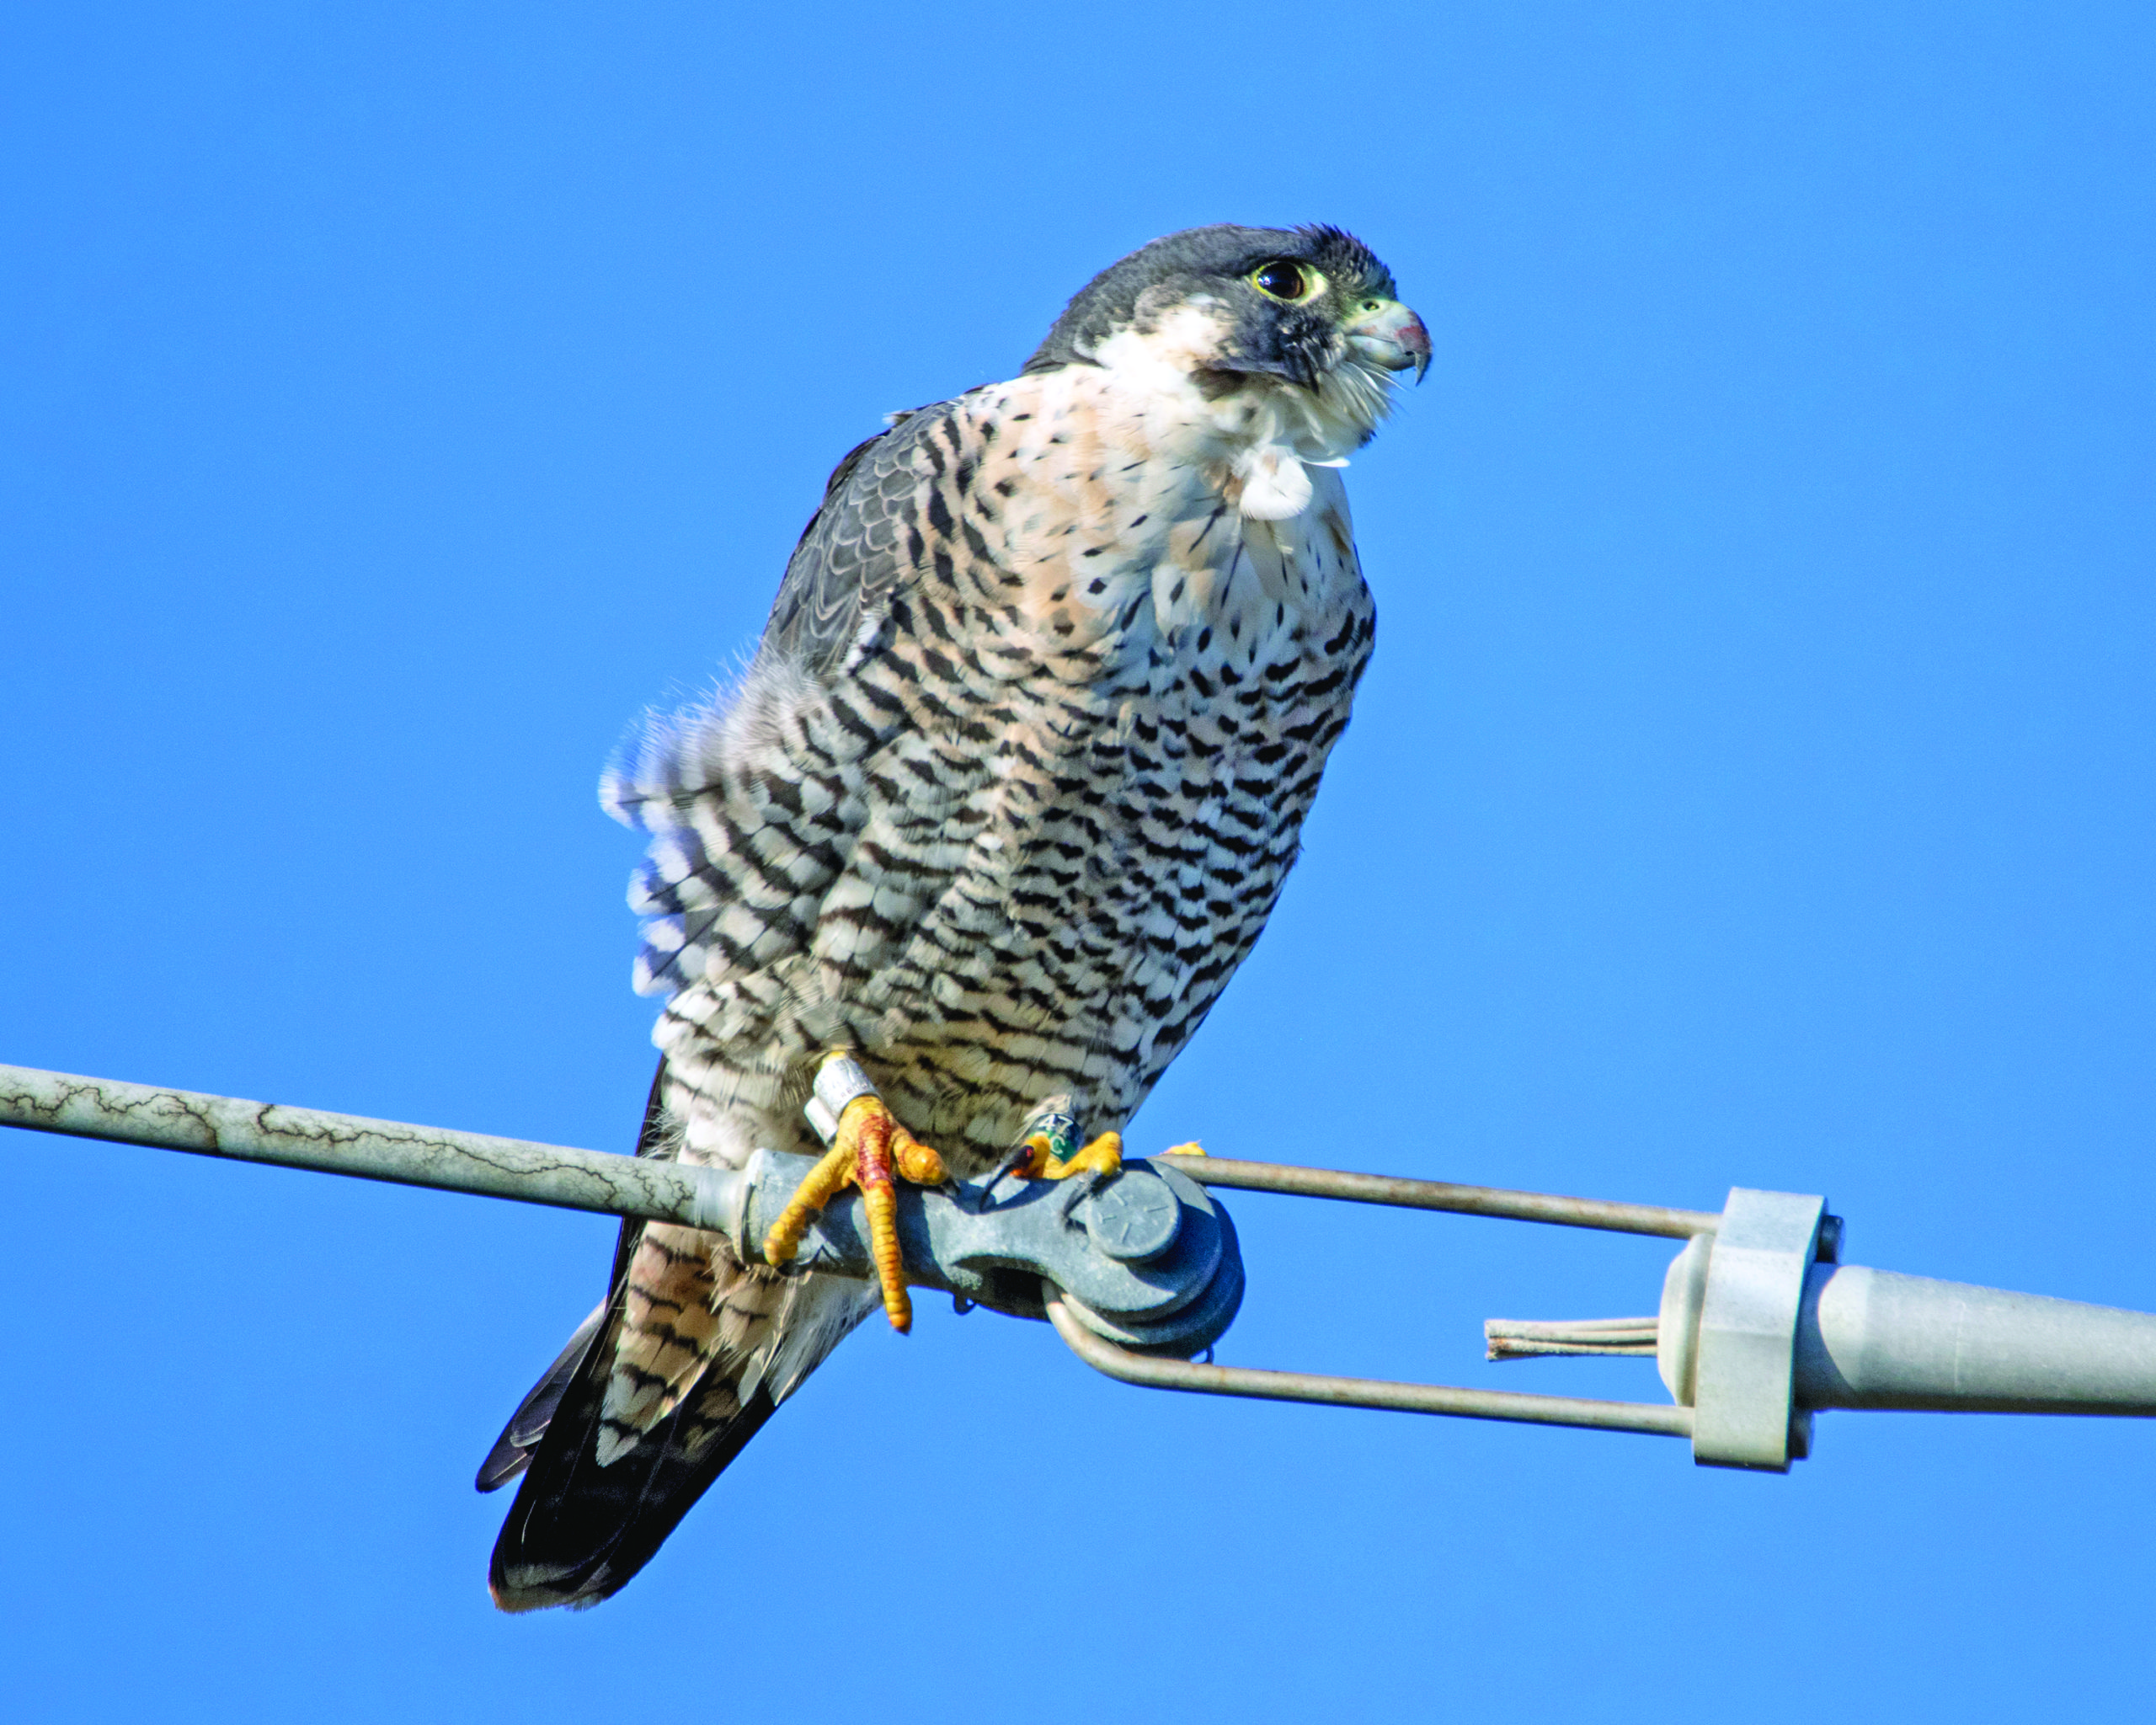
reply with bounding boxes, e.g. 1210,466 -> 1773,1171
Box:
0,0 -> 2156,1725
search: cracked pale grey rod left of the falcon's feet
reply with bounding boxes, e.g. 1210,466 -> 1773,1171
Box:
0,1065 -> 720,1227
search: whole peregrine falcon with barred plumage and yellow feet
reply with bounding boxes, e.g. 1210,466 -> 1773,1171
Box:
478,227 -> 1429,1610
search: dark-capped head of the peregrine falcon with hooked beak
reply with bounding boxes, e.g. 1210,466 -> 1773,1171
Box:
1027,224 -> 1429,442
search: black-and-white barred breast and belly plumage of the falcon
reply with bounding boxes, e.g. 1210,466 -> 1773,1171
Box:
612,357 -> 1374,1171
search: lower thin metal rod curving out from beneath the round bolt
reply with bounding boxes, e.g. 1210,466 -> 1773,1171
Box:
1048,1294 -> 1693,1439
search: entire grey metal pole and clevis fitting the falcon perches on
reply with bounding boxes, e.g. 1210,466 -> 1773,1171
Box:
13,1065 -> 2156,1472
